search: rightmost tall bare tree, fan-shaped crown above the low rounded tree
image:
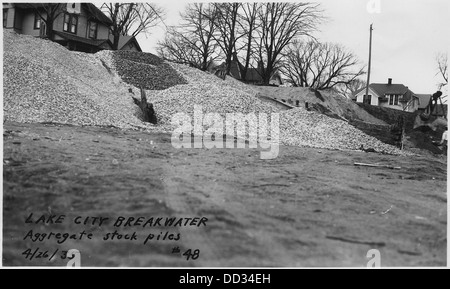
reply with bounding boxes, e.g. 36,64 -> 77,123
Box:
256,2 -> 322,84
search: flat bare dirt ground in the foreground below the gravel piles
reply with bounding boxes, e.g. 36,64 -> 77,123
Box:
3,123 -> 447,267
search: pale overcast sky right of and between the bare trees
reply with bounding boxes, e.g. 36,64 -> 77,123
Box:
134,0 -> 450,93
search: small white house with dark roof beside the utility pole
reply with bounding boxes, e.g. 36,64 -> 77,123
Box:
354,78 -> 420,112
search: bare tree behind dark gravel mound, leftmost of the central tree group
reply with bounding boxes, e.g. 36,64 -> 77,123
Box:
158,3 -> 218,71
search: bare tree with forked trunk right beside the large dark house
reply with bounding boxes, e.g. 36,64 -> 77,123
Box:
101,3 -> 165,50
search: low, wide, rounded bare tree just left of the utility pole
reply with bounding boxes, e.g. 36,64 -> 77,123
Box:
282,41 -> 365,90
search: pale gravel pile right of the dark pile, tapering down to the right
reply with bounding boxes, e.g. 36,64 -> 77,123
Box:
141,64 -> 402,154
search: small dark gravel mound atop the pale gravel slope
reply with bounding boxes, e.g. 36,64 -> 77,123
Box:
112,51 -> 187,90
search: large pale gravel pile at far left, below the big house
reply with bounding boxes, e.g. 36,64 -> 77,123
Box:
3,31 -> 151,128
